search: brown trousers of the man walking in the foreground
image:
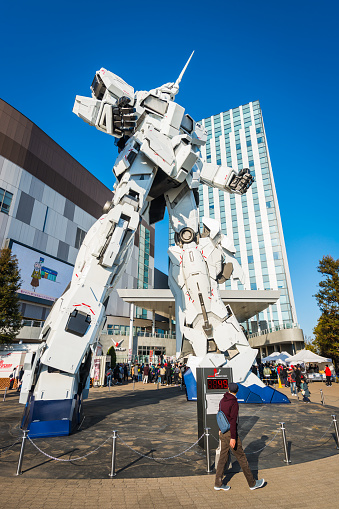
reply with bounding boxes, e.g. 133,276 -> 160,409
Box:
214,431 -> 255,488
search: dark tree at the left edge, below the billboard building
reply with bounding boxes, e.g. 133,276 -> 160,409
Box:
0,248 -> 22,343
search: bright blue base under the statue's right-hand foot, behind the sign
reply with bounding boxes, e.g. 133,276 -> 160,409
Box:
184,369 -> 291,404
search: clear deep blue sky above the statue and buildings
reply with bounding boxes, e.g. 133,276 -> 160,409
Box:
0,0 -> 339,335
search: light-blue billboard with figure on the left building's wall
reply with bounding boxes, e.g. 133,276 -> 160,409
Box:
12,242 -> 73,302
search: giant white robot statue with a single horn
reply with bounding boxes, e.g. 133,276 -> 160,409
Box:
20,55 -> 276,436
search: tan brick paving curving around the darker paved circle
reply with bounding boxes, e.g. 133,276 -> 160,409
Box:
0,383 -> 339,509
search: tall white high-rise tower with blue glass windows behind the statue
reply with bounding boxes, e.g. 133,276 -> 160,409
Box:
170,101 -> 297,333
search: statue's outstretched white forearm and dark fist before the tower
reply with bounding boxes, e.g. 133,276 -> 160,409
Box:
200,162 -> 254,194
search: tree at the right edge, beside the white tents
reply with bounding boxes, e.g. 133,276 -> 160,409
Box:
313,255 -> 339,365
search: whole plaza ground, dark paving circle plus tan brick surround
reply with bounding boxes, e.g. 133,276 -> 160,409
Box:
0,383 -> 339,509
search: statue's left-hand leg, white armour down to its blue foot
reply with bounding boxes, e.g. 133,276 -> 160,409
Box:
20,152 -> 152,436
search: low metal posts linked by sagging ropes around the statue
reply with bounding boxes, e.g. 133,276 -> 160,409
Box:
0,414 -> 339,478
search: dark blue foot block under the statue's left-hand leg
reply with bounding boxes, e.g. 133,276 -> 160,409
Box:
21,396 -> 81,438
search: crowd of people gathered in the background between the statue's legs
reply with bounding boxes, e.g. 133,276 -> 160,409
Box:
105,361 -> 187,386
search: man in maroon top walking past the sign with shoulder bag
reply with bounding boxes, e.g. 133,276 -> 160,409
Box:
214,383 -> 265,491
